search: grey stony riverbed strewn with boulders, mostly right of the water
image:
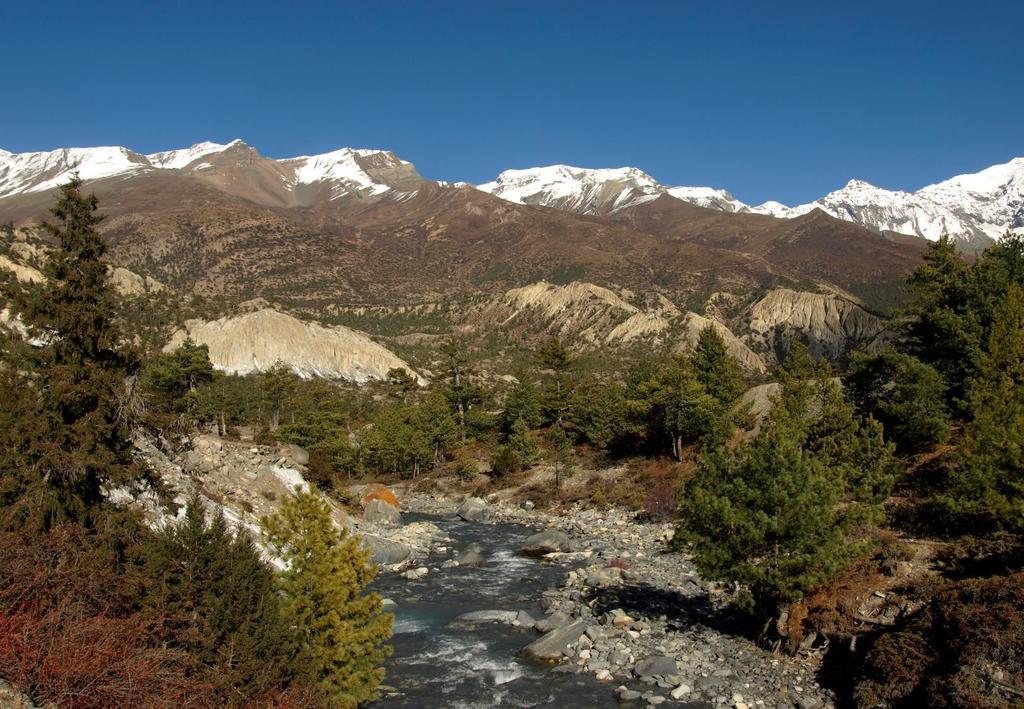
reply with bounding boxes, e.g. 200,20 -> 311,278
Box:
385,494 -> 834,709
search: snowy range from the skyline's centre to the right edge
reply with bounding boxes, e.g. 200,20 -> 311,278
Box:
478,158 -> 1024,246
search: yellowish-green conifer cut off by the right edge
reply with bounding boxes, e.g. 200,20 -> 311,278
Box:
943,285 -> 1024,531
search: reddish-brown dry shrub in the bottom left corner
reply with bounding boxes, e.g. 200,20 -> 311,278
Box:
0,525 -> 207,709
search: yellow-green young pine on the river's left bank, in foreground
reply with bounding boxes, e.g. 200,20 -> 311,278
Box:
263,492 -> 392,709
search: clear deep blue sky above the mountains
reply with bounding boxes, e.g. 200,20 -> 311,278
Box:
0,0 -> 1024,204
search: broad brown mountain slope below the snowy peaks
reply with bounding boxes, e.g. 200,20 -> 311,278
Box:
0,169 -> 920,309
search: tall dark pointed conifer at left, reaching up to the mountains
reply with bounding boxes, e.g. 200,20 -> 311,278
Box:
0,176 -> 139,527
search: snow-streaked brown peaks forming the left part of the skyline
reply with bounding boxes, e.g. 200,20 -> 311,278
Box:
0,140 -> 423,205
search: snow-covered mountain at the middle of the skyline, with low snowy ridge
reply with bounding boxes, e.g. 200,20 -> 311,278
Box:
477,165 -> 746,215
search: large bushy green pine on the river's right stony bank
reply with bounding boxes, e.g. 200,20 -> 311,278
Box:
677,347 -> 895,614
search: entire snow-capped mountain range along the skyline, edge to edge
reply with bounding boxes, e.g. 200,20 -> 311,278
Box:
0,140 -> 1024,247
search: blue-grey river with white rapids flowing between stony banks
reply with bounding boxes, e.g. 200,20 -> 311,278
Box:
372,514 -> 617,709
